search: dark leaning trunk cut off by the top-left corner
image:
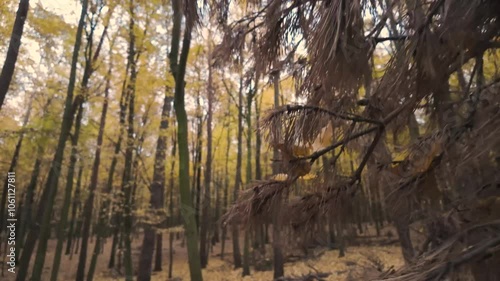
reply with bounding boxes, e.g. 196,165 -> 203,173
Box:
0,0 -> 30,109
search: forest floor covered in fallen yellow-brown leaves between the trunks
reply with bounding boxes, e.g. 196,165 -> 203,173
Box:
0,225 -> 403,281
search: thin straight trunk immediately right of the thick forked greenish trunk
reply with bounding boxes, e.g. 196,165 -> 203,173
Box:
200,47 -> 214,268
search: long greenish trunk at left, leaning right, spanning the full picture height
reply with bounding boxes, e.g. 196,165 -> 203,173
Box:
16,0 -> 88,281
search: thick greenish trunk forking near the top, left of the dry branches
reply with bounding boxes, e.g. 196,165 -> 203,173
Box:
170,0 -> 203,276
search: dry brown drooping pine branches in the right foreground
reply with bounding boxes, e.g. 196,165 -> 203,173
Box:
217,0 -> 500,280
